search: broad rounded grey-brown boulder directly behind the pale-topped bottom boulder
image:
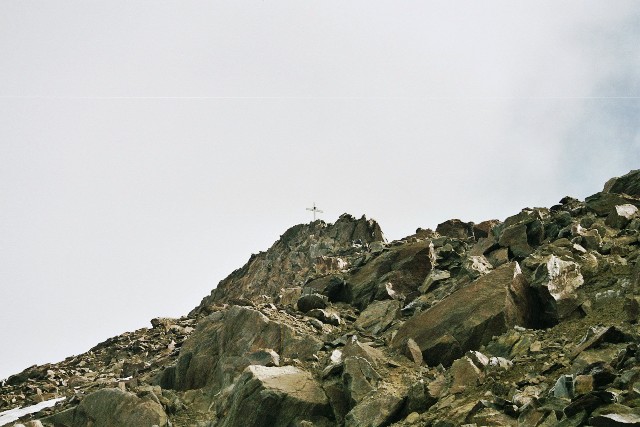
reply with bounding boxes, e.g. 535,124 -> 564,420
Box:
164,306 -> 322,390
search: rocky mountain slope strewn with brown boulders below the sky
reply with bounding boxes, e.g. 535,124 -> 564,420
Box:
0,171 -> 640,427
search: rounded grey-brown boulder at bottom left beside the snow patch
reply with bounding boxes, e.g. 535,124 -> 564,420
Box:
43,388 -> 168,427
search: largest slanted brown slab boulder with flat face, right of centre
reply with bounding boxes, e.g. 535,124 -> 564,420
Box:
391,262 -> 537,366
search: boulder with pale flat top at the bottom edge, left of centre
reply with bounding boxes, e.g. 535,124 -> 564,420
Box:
217,365 -> 333,427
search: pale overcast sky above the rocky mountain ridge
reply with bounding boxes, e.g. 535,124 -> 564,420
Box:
0,0 -> 640,378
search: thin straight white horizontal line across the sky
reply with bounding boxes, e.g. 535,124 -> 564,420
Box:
0,96 -> 640,101
